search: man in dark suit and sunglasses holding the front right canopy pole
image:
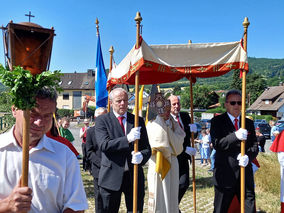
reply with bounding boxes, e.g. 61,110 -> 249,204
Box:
210,90 -> 258,213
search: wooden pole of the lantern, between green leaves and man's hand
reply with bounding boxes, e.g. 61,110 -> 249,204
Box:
21,110 -> 30,189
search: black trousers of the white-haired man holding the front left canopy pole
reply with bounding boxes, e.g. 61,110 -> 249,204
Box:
99,171 -> 145,213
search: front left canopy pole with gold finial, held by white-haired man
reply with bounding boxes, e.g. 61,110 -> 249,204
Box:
133,12 -> 142,213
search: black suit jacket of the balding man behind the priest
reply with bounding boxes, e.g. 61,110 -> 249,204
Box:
177,112 -> 191,163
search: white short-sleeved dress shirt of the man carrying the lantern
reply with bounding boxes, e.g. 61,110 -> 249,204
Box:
0,126 -> 88,213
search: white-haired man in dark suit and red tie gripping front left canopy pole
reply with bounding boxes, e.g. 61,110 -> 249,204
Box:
95,88 -> 151,213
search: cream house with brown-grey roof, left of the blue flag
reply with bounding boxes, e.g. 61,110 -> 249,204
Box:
57,69 -> 96,110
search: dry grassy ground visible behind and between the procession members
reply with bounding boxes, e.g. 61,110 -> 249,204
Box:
82,153 -> 280,213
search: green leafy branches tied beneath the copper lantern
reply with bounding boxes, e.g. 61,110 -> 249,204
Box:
0,64 -> 63,110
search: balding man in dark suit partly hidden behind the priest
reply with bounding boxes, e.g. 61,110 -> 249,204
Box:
168,95 -> 197,208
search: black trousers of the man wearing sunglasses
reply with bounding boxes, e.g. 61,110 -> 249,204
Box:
214,181 -> 255,213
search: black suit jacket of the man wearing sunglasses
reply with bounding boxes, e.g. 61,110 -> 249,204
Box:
210,113 -> 258,188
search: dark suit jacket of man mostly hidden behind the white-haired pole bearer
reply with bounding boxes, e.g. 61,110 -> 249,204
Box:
86,126 -> 101,178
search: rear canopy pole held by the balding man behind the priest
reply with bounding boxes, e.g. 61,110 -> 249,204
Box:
190,78 -> 196,213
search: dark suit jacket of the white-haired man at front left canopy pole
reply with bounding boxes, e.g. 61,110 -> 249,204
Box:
95,111 -> 151,191
